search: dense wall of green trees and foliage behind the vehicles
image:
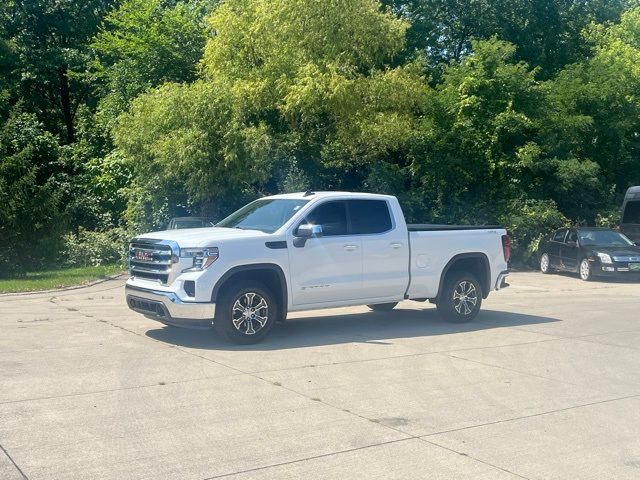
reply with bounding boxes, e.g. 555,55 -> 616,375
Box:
0,0 -> 640,276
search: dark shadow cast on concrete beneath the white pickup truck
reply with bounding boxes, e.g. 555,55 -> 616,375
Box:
146,308 -> 559,351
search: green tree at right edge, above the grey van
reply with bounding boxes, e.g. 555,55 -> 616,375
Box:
546,8 -> 640,193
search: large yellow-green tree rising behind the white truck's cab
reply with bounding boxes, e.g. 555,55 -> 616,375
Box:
116,0 -> 428,227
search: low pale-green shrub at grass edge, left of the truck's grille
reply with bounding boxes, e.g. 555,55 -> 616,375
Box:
63,227 -> 131,267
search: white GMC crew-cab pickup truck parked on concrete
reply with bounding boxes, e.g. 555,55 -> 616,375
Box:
125,192 -> 510,344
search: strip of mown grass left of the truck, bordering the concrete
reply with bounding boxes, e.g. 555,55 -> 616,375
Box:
0,265 -> 125,293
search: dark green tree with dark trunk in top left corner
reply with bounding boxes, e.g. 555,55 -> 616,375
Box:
0,0 -> 115,143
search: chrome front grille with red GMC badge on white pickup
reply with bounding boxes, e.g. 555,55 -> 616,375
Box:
129,239 -> 180,285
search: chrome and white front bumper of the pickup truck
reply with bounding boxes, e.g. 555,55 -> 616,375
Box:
125,285 -> 216,327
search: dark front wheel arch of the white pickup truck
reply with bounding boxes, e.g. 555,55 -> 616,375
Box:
211,263 -> 288,319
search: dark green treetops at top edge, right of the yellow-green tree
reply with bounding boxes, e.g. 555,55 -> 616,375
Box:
384,0 -> 637,78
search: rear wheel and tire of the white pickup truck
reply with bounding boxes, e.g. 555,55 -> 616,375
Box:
437,273 -> 482,323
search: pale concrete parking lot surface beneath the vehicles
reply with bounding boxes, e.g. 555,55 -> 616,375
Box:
0,273 -> 640,480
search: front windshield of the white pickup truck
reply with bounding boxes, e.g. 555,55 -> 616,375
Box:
216,198 -> 308,233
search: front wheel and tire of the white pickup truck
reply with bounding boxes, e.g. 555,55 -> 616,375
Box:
213,282 -> 279,345
